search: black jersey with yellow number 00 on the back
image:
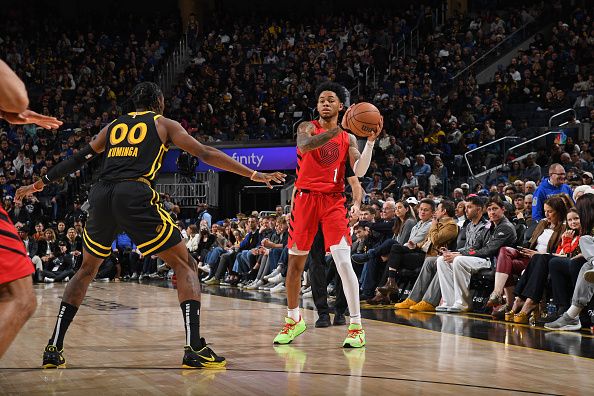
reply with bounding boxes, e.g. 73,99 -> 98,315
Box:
99,111 -> 169,182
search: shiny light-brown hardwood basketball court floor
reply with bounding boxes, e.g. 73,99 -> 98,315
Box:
0,283 -> 594,396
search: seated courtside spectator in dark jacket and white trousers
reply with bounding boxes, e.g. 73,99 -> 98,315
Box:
436,196 -> 516,313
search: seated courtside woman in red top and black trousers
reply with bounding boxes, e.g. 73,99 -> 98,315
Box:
505,208 -> 580,323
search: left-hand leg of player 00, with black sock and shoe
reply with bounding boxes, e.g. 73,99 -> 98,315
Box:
43,246 -> 104,368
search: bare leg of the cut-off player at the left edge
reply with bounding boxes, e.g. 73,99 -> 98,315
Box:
0,275 -> 37,358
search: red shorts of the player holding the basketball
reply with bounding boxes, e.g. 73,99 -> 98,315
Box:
288,190 -> 351,251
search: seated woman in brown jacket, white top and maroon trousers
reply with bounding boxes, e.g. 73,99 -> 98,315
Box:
487,196 -> 567,307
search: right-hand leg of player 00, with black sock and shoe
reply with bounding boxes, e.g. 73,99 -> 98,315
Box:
157,241 -> 227,368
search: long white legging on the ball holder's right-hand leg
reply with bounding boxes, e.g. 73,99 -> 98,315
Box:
330,243 -> 361,324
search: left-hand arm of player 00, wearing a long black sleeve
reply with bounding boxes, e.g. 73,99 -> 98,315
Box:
14,127 -> 107,202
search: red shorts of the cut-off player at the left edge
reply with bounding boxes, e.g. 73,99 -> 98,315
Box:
0,206 -> 35,284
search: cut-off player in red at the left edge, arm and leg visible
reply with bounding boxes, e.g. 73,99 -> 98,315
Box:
0,60 -> 62,358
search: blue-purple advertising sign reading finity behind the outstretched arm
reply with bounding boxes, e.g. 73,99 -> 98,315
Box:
162,146 -> 297,173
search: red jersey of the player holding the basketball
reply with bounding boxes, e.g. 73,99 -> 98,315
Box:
295,121 -> 350,193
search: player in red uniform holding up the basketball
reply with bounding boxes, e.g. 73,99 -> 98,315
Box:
274,82 -> 383,348
